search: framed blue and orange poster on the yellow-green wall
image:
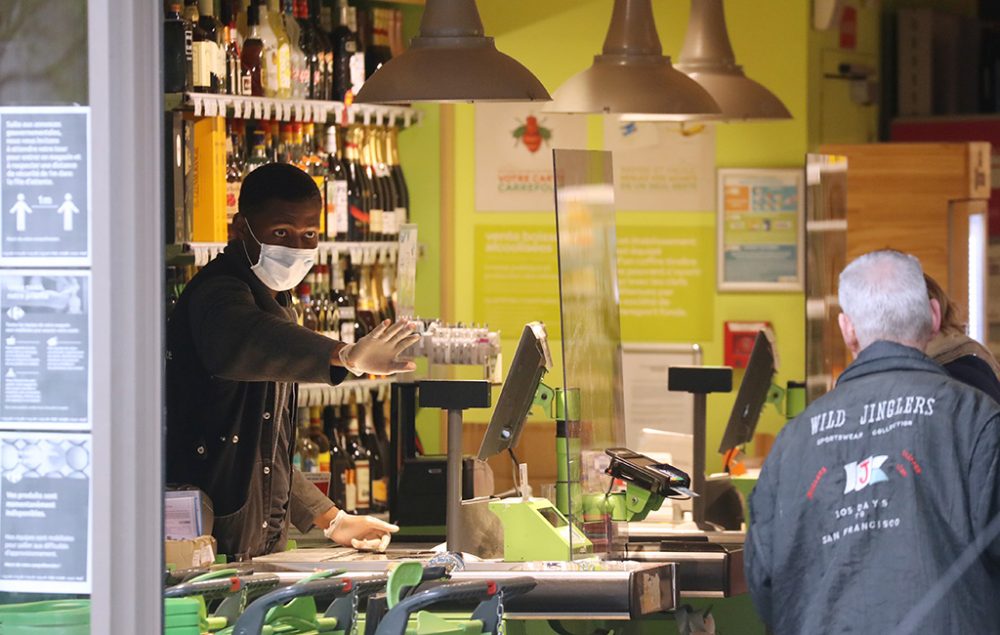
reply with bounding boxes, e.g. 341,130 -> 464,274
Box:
718,170 -> 805,291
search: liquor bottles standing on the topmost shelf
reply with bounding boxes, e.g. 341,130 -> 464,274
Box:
163,0 -> 403,102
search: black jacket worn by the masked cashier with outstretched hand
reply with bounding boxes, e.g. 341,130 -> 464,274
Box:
166,242 -> 347,516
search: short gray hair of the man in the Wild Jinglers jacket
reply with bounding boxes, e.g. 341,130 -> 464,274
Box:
838,249 -> 933,349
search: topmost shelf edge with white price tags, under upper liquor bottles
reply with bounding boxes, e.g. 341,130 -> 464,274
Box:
178,93 -> 423,128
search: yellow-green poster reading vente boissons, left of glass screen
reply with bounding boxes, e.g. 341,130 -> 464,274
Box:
473,225 -> 561,340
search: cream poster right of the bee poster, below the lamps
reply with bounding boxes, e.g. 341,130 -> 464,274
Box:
604,121 -> 715,212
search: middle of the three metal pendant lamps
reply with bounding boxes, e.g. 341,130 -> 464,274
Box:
543,0 -> 719,121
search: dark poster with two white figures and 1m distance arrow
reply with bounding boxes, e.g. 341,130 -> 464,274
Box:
0,107 -> 90,266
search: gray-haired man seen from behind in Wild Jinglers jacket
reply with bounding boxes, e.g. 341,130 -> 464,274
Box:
746,251 -> 1000,635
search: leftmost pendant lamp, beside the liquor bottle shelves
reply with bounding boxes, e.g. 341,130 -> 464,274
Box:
354,0 -> 551,104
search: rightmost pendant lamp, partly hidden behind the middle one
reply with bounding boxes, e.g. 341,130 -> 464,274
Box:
677,0 -> 792,119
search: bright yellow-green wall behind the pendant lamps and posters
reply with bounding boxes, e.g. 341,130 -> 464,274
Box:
428,0 -> 809,470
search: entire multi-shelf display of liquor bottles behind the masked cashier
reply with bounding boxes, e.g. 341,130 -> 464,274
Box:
163,0 -> 409,528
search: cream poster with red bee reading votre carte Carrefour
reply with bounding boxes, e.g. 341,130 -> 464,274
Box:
475,103 -> 587,213
